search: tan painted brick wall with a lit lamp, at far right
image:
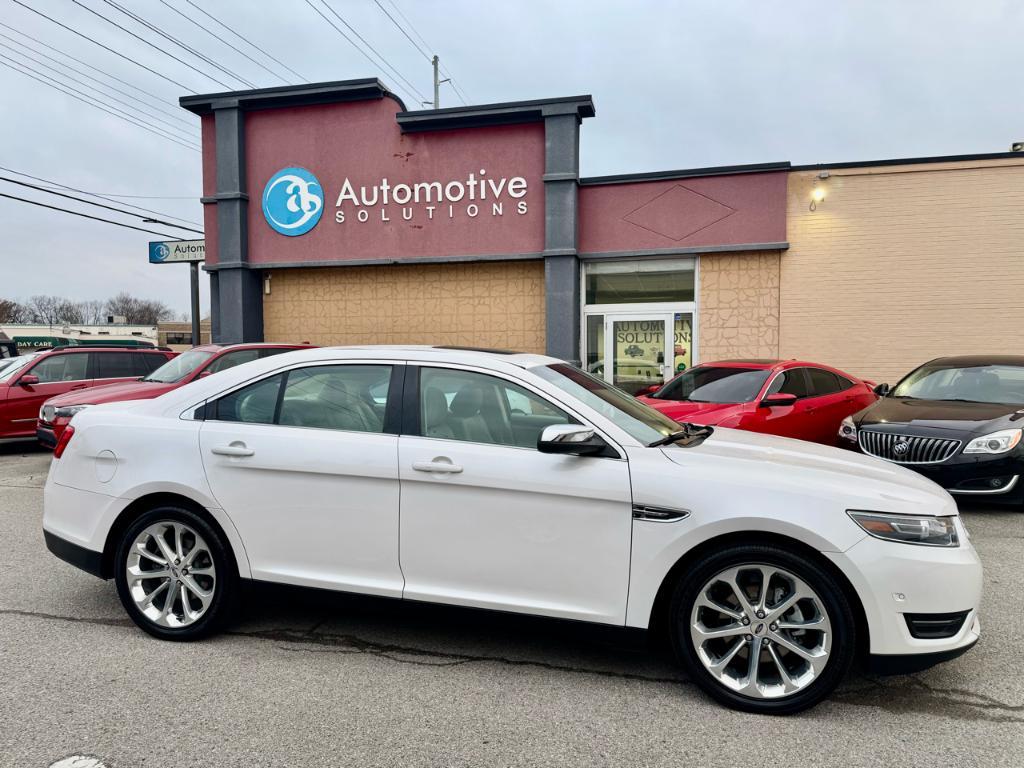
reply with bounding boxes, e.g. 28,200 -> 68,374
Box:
779,158 -> 1024,383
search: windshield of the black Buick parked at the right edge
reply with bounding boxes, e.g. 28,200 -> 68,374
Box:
890,364 -> 1024,406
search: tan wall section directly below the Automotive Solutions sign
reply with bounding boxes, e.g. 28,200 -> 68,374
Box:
263,260 -> 545,352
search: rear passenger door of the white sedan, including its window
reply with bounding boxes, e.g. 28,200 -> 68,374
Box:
200,361 -> 402,597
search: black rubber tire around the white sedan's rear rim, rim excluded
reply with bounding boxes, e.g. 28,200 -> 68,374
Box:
114,506 -> 239,641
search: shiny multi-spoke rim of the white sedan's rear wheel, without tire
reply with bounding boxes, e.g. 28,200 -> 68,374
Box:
125,520 -> 217,629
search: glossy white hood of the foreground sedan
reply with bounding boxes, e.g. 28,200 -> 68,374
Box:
663,427 -> 956,514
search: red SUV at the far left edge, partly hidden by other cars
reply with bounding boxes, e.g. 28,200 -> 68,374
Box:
0,346 -> 177,438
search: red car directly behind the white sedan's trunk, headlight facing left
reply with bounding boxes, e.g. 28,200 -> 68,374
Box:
37,344 -> 310,449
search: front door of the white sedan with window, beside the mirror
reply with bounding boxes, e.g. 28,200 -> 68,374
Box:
398,365 -> 632,624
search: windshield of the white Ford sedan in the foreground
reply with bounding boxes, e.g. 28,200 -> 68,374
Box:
532,362 -> 682,445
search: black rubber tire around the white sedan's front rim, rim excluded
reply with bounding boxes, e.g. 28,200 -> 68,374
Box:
669,544 -> 857,715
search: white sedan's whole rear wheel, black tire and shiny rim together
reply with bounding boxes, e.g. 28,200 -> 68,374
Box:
114,507 -> 238,640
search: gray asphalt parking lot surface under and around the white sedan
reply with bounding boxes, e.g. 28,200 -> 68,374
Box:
0,444 -> 1024,768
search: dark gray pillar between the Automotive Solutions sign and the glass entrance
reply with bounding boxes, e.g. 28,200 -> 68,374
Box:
544,110 -> 580,365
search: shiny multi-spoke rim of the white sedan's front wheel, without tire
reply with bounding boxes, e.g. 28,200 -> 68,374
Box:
690,564 -> 833,698
